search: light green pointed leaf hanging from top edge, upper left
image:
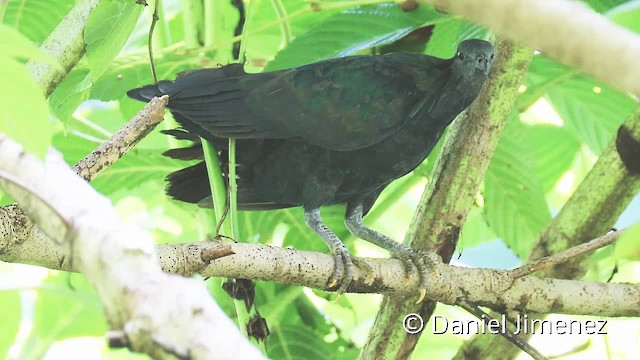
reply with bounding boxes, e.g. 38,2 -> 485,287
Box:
84,0 -> 144,81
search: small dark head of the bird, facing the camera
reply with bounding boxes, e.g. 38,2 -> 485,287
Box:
453,39 -> 493,77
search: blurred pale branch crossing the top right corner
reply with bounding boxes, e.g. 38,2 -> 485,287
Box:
422,0 -> 640,96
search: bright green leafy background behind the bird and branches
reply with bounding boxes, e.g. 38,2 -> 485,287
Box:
0,0 -> 640,359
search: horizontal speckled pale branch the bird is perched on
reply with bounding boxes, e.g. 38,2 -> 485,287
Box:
0,226 -> 640,316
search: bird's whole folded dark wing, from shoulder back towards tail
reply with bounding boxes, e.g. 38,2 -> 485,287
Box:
130,53 -> 449,151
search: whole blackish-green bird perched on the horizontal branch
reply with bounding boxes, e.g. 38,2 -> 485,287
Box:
127,39 -> 493,292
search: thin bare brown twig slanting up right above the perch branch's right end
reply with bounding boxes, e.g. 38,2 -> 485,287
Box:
507,230 -> 624,279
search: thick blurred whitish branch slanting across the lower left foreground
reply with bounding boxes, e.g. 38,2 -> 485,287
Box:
0,136 -> 261,359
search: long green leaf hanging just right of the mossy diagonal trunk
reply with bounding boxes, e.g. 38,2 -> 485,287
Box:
484,115 -> 551,259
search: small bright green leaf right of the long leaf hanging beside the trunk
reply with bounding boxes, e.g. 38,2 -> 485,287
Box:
526,125 -> 580,192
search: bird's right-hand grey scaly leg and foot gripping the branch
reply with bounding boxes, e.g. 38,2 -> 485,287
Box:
345,203 -> 428,302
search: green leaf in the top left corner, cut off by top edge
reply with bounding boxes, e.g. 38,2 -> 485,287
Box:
3,0 -> 76,43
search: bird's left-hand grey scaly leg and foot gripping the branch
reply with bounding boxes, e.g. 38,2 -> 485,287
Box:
304,208 -> 354,294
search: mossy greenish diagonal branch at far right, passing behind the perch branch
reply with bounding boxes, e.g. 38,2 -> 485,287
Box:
457,45 -> 640,359
